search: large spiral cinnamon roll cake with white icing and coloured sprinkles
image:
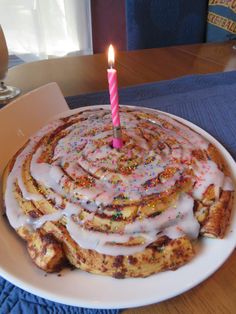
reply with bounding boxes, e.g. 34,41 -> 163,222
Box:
3,107 -> 233,278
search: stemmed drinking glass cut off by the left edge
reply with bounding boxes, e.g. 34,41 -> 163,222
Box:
0,25 -> 20,104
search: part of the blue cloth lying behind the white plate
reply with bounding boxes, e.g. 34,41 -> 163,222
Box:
67,71 -> 236,158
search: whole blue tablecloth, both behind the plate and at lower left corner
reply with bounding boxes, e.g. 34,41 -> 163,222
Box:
0,71 -> 236,314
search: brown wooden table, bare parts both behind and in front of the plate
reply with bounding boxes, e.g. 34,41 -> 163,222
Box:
4,42 -> 236,314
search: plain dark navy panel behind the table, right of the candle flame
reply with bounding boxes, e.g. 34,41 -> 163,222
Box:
126,0 -> 208,50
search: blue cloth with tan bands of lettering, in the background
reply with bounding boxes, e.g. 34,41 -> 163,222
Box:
206,0 -> 236,42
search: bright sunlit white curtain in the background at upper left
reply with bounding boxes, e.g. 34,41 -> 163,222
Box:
0,0 -> 92,59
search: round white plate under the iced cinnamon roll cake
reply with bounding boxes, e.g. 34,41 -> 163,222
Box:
0,106 -> 236,308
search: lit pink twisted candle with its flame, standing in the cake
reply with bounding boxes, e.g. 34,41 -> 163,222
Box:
107,45 -> 123,148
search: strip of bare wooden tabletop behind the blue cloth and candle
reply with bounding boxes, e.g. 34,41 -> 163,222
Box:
6,41 -> 236,96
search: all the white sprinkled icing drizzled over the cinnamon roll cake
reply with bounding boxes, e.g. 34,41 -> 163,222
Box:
5,106 -> 233,256
